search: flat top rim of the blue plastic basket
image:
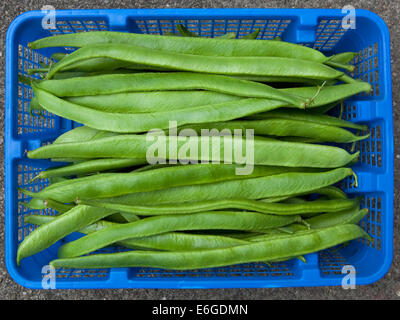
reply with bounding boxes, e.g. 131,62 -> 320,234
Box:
4,8 -> 394,289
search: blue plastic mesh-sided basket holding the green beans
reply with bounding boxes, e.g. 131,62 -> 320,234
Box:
5,9 -> 393,289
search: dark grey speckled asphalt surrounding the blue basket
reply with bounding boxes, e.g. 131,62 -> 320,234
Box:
0,0 -> 400,300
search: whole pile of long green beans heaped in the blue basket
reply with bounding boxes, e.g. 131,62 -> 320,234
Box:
17,30 -> 371,270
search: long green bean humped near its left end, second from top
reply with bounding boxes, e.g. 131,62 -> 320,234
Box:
47,40 -> 343,80
